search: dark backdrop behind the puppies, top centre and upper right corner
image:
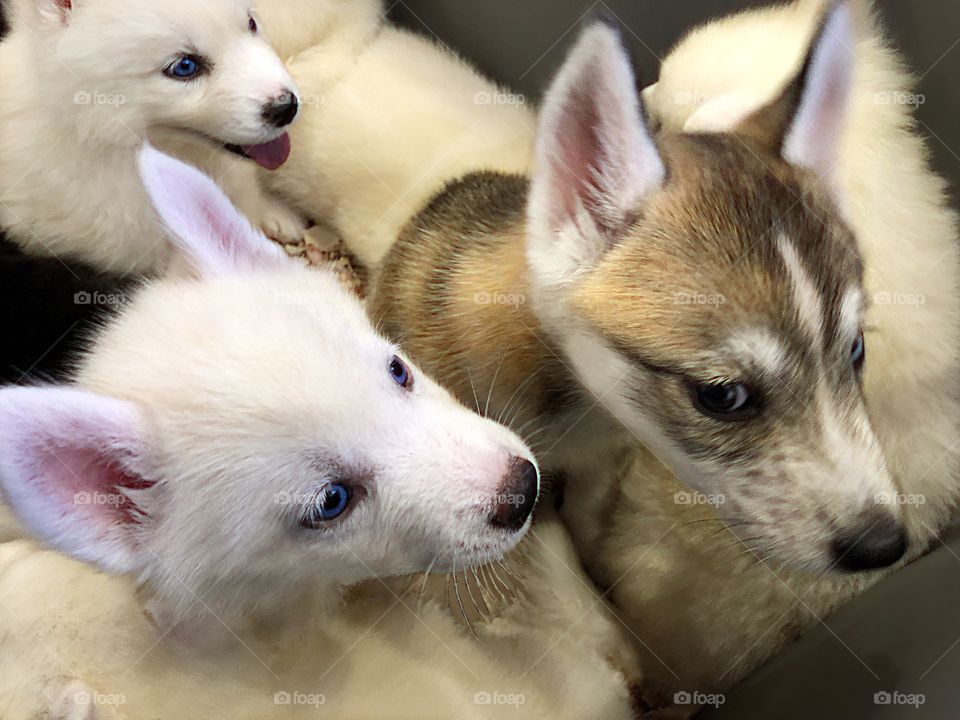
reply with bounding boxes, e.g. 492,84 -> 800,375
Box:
0,0 -> 960,197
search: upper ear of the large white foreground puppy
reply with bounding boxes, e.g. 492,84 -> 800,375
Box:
139,144 -> 289,277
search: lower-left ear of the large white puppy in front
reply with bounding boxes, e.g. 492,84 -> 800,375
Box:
0,388 -> 155,572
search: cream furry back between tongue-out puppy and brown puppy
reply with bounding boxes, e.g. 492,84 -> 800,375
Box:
260,21 -> 536,267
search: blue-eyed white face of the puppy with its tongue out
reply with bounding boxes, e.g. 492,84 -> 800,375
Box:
30,0 -> 299,164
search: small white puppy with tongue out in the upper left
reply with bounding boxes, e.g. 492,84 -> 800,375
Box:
0,0 -> 299,272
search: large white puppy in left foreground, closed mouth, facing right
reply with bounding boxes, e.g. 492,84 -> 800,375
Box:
0,143 -> 636,720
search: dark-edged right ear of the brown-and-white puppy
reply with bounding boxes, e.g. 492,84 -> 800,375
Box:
737,0 -> 855,176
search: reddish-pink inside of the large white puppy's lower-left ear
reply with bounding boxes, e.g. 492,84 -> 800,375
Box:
37,447 -> 153,529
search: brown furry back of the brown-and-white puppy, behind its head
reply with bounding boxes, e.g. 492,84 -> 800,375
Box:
371,172 -> 573,438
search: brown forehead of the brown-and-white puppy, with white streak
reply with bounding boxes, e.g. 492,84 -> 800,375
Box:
574,135 -> 863,362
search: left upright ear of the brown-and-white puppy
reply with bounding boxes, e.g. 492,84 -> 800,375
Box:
528,22 -> 665,283
